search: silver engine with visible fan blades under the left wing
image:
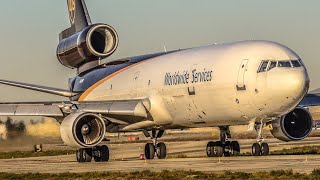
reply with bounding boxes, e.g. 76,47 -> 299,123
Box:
60,112 -> 106,148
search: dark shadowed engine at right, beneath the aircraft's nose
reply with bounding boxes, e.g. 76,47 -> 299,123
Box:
271,108 -> 313,142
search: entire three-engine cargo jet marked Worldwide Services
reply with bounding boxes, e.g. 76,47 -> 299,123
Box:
0,0 -> 312,162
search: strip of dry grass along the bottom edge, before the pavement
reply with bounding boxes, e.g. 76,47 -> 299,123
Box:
0,169 -> 320,180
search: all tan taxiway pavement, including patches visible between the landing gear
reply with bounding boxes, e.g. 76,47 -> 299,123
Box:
0,138 -> 320,173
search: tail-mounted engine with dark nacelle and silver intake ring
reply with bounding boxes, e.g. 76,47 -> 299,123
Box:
57,24 -> 119,68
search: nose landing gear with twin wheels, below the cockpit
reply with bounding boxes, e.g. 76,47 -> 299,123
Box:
251,122 -> 269,156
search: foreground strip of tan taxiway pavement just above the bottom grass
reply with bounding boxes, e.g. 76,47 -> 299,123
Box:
0,155 -> 320,173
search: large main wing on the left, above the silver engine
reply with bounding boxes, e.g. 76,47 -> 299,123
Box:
0,99 -> 150,124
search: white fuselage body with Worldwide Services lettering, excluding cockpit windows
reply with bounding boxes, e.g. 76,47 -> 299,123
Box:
79,41 -> 309,127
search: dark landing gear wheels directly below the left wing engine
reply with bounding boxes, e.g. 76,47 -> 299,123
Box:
76,145 -> 109,163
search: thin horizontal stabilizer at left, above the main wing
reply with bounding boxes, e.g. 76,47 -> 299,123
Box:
0,80 -> 78,97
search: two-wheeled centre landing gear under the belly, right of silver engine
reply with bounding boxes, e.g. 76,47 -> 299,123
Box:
143,129 -> 167,159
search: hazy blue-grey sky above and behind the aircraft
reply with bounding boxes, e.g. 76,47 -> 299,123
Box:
0,0 -> 320,101
